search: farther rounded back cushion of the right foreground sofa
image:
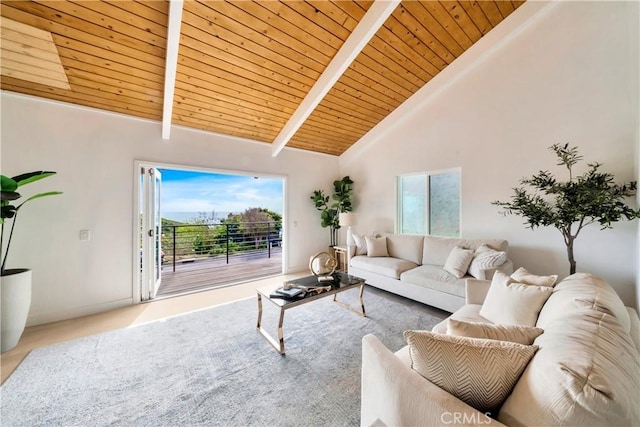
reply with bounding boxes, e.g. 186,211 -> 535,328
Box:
536,273 -> 631,332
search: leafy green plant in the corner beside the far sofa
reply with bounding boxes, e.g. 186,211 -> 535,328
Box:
311,176 -> 353,246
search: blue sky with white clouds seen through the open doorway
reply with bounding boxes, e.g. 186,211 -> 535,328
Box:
161,169 -> 283,214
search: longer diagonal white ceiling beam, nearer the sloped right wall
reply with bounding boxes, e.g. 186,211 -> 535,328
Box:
271,0 -> 400,157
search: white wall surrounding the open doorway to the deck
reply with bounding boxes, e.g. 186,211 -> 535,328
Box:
1,92 -> 339,325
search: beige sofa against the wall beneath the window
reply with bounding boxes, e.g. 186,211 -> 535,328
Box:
347,234 -> 513,312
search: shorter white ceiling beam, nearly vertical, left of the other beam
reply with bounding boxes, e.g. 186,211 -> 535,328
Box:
162,0 -> 184,139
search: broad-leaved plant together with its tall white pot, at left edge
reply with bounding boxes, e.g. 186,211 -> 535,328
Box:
0,171 -> 62,353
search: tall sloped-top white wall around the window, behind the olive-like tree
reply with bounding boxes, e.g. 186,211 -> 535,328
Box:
340,2 -> 639,306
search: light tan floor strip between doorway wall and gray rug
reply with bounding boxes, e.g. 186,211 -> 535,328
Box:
0,272 -> 308,382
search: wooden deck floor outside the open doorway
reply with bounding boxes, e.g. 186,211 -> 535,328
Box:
157,247 -> 282,297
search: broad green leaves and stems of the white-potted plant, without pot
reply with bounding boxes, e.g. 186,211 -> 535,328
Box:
0,171 -> 62,276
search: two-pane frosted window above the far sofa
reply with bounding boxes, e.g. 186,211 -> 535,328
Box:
398,169 -> 460,237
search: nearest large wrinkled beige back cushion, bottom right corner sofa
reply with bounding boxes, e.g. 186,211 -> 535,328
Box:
498,310 -> 640,426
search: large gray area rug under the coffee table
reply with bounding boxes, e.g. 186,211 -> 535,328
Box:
1,288 -> 444,426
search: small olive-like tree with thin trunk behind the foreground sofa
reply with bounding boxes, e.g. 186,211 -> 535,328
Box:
493,144 -> 640,274
